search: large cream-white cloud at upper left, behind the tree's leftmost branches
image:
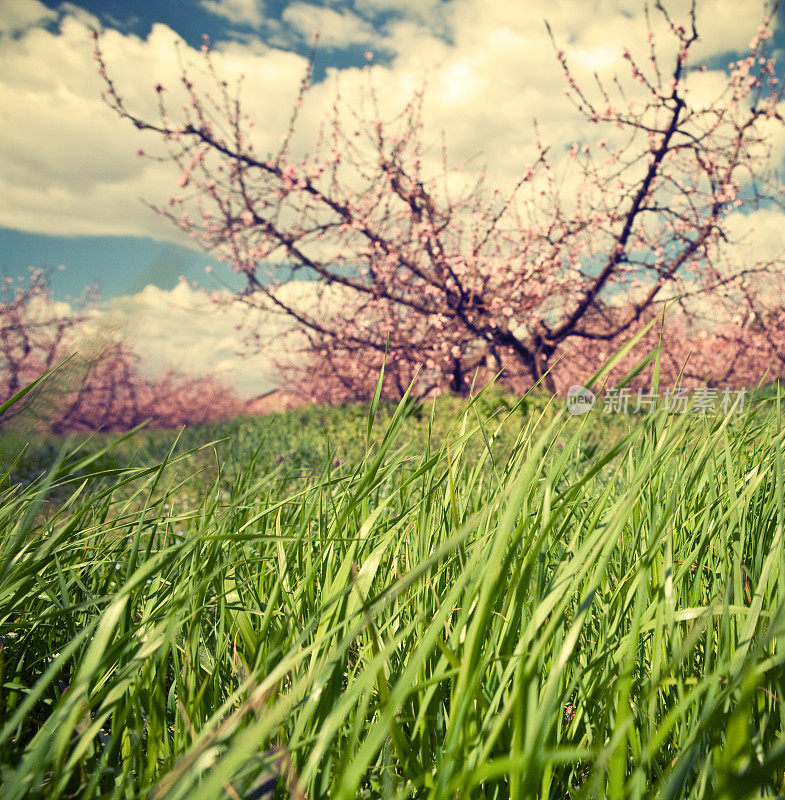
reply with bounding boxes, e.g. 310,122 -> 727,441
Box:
0,15 -> 305,244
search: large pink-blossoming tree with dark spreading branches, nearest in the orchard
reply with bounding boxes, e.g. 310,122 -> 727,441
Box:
95,2 -> 783,400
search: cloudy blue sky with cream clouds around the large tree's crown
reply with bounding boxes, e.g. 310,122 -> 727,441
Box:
0,0 -> 785,393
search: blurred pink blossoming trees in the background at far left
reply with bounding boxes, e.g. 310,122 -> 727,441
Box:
0,269 -> 243,433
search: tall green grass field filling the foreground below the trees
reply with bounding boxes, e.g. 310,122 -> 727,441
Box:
0,372 -> 785,800
